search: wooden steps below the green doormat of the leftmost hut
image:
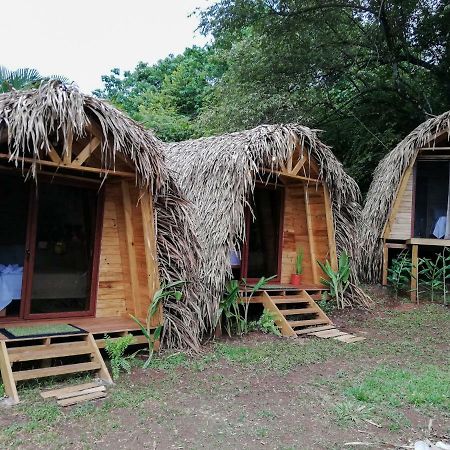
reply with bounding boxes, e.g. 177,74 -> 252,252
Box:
0,333 -> 112,404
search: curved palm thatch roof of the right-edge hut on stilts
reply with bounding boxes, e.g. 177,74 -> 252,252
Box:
358,111 -> 450,282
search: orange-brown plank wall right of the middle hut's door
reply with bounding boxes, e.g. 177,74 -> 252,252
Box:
281,183 -> 330,284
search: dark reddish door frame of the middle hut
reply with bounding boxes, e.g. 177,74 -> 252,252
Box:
240,181 -> 286,283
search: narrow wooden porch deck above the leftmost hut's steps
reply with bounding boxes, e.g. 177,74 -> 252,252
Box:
0,317 -> 149,348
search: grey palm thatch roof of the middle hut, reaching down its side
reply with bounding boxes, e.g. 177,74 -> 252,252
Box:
166,124 -> 370,338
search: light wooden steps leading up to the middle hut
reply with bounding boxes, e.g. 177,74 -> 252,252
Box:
243,289 -> 334,336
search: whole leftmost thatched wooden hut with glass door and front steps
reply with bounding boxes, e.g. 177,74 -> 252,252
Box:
0,82 -> 199,402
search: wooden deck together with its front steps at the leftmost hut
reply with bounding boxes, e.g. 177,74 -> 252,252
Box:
0,318 -> 156,404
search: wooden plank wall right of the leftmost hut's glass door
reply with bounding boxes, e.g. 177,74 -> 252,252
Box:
96,182 -> 158,317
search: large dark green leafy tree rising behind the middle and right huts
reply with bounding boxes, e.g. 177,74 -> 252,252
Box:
199,0 -> 450,189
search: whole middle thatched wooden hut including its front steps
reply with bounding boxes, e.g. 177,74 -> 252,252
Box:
166,125 -> 359,335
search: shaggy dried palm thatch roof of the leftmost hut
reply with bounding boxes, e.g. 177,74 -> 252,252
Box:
0,81 -> 200,348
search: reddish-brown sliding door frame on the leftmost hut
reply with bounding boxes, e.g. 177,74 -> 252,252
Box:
19,176 -> 105,320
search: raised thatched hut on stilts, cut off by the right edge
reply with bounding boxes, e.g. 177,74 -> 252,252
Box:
359,111 -> 450,282
